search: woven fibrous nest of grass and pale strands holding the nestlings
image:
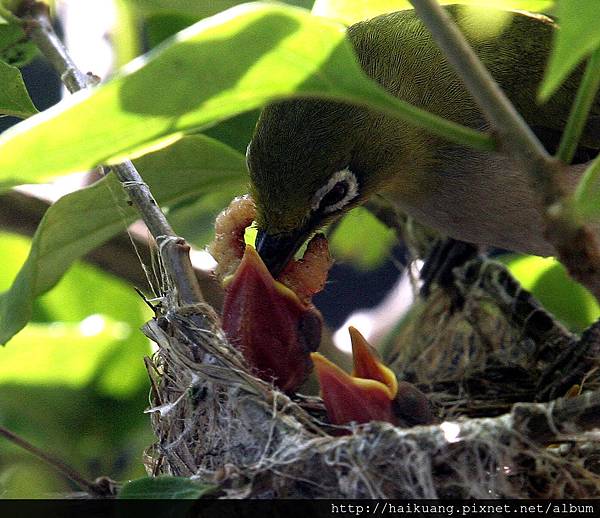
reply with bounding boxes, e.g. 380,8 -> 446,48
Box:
145,259 -> 600,498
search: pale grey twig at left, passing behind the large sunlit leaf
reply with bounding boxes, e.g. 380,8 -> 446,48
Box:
19,0 -> 203,305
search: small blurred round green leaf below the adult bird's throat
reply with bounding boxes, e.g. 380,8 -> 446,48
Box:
330,207 -> 396,270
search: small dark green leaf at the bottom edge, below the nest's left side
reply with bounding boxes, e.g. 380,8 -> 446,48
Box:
118,477 -> 216,500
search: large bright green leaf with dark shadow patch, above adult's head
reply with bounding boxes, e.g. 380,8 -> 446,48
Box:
0,3 -> 493,190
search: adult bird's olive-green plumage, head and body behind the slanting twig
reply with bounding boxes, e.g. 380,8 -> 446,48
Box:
247,6 -> 600,272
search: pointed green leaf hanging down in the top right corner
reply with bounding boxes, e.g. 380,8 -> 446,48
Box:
539,0 -> 600,101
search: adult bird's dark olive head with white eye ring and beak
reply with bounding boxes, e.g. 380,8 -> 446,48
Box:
247,99 -> 404,276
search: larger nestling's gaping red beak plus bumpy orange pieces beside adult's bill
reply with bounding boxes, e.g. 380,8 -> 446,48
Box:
209,196 -> 332,393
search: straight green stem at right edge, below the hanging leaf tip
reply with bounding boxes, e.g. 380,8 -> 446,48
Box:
556,47 -> 600,164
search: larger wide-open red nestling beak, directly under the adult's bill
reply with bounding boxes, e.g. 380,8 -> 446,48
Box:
223,246 -> 322,392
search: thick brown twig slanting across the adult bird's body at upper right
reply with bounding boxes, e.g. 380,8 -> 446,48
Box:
410,0 -> 600,300
